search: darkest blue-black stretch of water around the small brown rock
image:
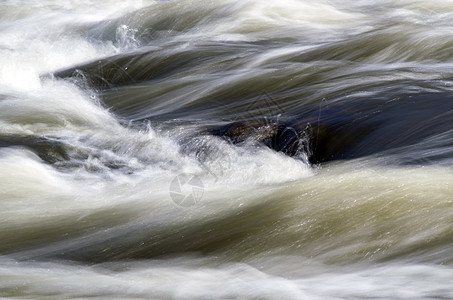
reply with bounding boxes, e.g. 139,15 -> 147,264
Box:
209,93 -> 453,164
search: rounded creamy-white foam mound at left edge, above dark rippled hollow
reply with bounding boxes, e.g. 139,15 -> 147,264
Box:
0,81 -> 119,134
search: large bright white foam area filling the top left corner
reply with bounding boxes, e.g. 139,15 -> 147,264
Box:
0,0 -> 154,92
